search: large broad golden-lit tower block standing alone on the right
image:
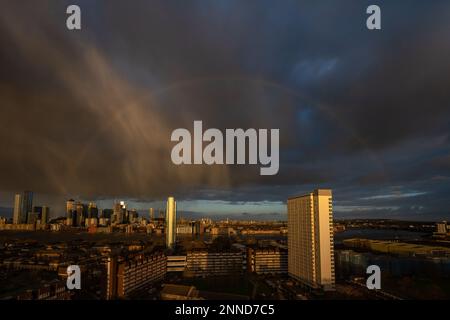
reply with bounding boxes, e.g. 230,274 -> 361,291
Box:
287,189 -> 335,290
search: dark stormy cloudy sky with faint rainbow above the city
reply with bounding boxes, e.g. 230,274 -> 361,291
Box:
0,0 -> 450,221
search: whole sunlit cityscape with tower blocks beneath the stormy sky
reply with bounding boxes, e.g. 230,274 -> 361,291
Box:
0,184 -> 450,300
